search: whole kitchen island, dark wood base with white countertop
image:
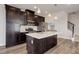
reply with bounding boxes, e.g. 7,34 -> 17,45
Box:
26,31 -> 57,54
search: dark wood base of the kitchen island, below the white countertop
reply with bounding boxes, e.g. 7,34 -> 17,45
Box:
27,35 -> 57,54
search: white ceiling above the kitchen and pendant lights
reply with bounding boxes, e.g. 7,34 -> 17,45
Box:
9,4 -> 79,16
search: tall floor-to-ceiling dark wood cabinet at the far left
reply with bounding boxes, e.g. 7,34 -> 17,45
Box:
5,5 -> 25,47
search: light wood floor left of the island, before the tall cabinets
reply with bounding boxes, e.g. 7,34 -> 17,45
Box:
0,43 -> 27,54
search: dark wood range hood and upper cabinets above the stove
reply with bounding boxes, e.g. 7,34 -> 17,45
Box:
25,9 -> 45,26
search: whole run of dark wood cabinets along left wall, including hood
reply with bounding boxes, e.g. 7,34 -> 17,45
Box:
5,5 -> 44,47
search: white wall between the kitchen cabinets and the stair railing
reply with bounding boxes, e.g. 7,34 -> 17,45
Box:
46,11 -> 71,39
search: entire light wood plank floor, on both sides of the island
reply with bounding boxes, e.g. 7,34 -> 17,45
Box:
0,39 -> 79,54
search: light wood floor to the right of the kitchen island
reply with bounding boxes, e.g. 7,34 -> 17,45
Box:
45,39 -> 79,54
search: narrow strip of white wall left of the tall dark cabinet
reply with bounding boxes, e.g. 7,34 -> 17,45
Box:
0,4 -> 6,46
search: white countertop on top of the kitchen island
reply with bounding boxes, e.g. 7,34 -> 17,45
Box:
26,31 -> 58,39
